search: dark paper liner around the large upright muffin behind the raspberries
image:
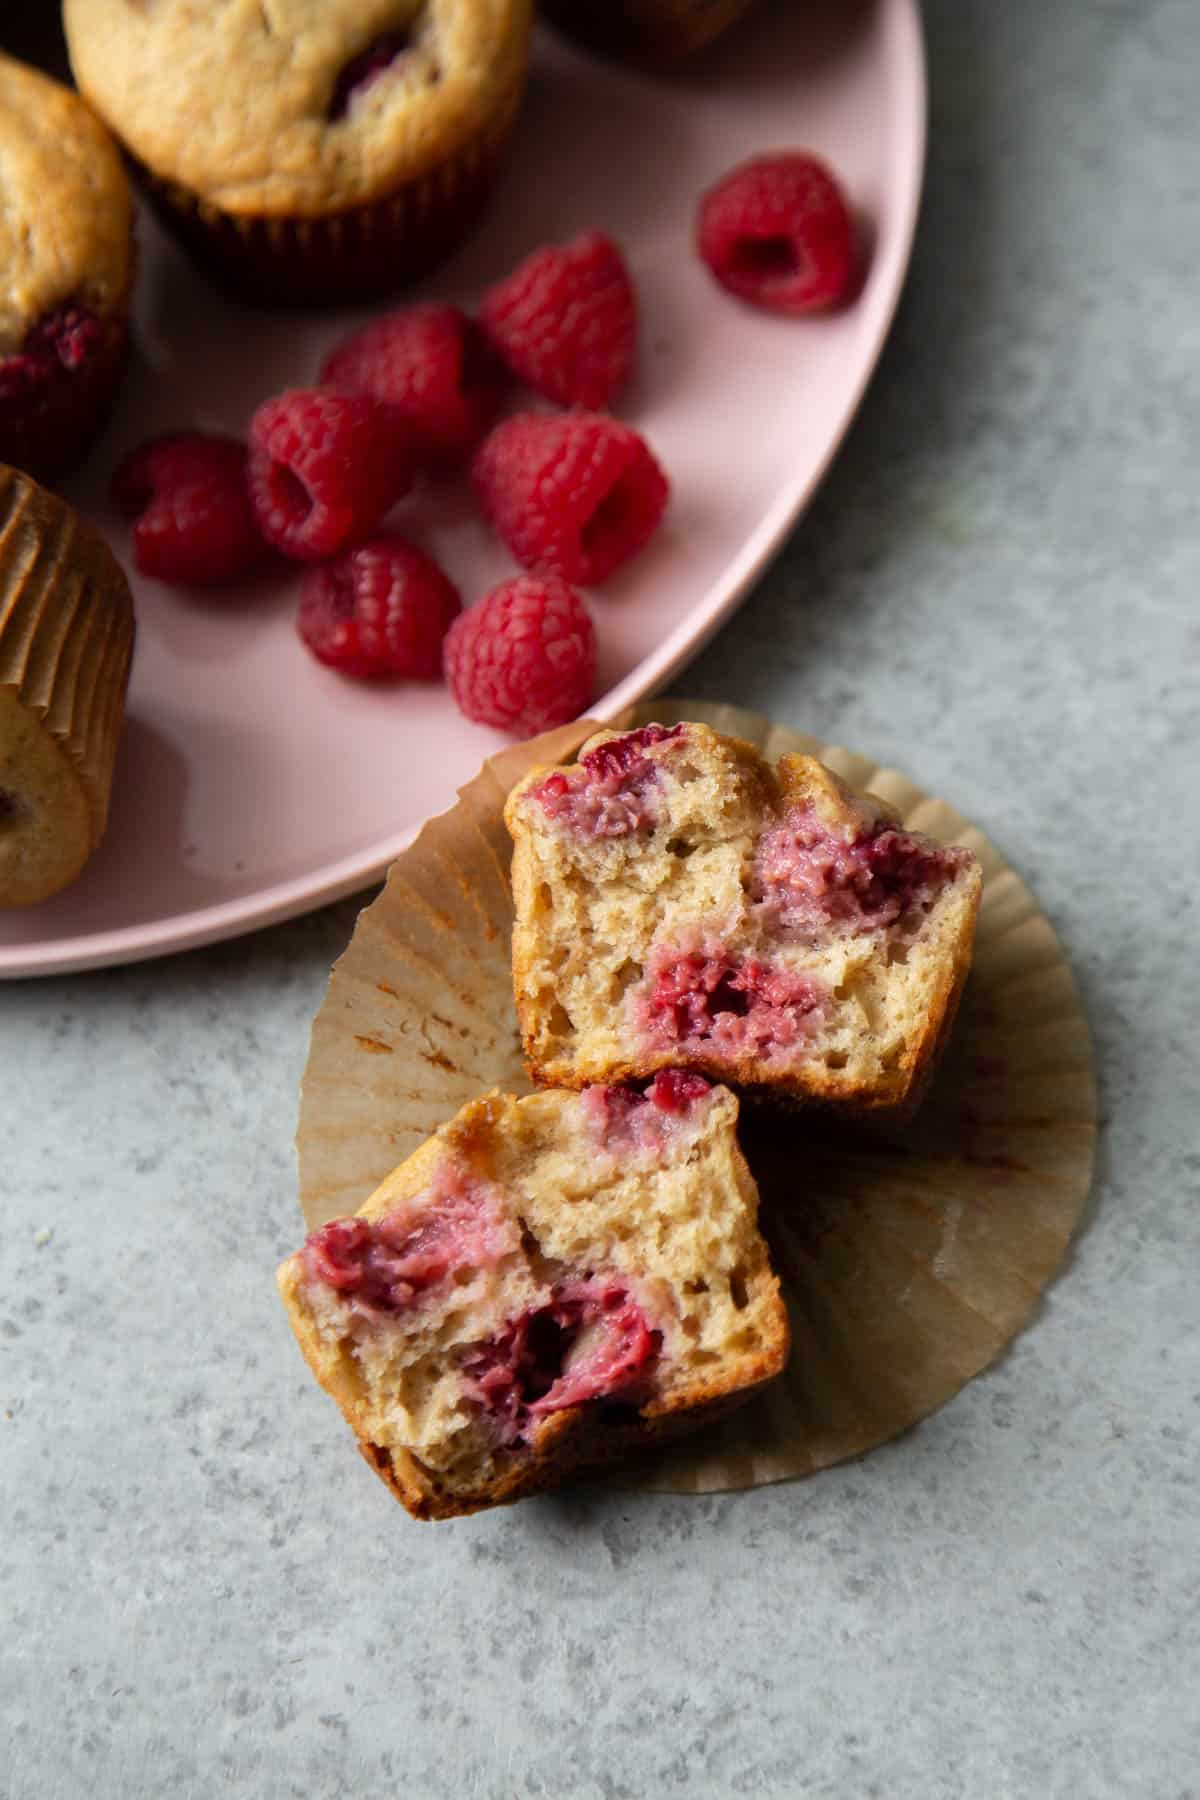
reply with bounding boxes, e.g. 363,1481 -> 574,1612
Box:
133,81 -> 524,306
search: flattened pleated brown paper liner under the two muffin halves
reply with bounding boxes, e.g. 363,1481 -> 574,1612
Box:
297,700 -> 1096,1494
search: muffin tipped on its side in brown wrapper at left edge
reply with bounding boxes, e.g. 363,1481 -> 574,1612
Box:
0,468 -> 133,905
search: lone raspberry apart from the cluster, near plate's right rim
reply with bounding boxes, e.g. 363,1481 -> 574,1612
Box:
696,151 -> 856,315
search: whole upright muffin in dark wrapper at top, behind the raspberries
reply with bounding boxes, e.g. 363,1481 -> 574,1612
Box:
63,0 -> 531,304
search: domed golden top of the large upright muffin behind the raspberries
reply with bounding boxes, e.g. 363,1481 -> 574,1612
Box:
63,0 -> 533,216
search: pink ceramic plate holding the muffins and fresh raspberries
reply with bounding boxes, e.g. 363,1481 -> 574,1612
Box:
0,0 -> 925,976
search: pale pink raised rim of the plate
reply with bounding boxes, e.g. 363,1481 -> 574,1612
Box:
0,0 -> 928,981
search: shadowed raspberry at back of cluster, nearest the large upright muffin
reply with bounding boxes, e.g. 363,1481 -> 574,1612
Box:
320,306 -> 504,464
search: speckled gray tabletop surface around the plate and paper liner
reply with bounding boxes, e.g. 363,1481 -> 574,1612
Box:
0,0 -> 1200,1800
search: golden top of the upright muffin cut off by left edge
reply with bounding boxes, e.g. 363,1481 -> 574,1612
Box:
0,56 -> 133,356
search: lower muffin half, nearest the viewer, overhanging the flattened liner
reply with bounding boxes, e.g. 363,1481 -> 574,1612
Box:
279,1073 -> 788,1519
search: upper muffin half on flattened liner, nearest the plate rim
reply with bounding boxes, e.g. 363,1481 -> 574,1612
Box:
506,724 -> 982,1111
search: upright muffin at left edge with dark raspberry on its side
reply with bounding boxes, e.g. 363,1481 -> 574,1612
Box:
0,56 -> 133,481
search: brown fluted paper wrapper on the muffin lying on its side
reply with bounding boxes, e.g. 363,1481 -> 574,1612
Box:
0,466 -> 135,850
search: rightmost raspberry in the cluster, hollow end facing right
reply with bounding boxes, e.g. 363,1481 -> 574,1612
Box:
471,412 -> 669,585
